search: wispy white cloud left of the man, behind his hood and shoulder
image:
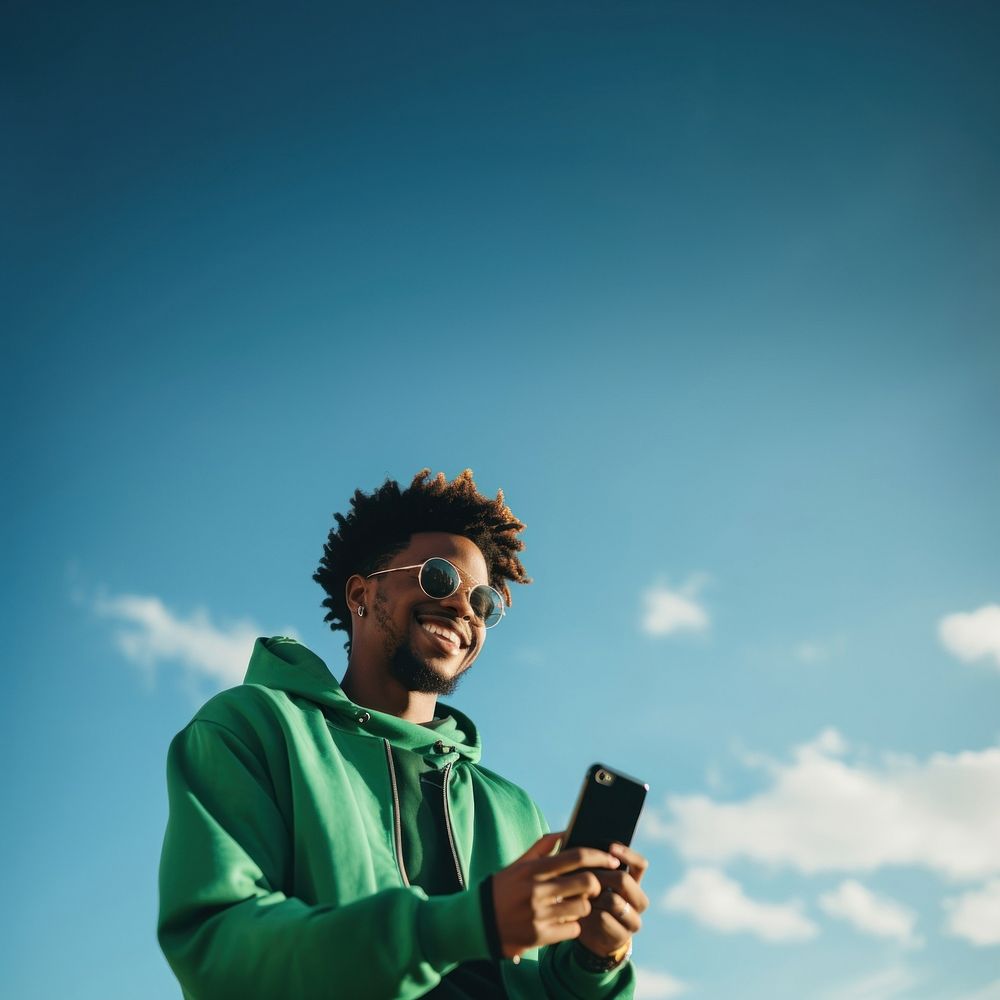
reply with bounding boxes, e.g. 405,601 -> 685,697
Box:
94,594 -> 290,688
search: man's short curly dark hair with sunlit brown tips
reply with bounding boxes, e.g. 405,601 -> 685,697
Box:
313,469 -> 531,649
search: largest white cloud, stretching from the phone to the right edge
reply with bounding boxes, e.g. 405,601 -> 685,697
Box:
643,729 -> 1000,879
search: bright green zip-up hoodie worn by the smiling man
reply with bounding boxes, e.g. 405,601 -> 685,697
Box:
158,637 -> 634,1000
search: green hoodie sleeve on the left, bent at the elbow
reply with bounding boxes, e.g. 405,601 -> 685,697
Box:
158,720 -> 489,1000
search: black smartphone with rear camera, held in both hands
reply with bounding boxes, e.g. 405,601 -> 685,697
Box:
561,764 -> 649,851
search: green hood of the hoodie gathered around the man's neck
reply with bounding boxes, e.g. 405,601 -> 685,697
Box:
243,636 -> 482,766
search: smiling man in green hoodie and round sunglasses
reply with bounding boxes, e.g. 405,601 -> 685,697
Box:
159,470 -> 648,1000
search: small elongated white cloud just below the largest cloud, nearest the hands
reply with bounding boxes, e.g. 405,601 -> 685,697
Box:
663,868 -> 817,941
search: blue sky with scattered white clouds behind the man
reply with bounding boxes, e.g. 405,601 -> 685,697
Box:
7,2 -> 1000,1000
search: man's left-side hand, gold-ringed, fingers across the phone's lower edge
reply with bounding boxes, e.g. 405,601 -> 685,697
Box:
493,833 -> 620,958
